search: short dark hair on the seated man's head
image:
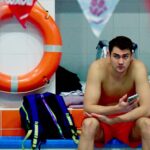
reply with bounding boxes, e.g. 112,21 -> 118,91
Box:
109,36 -> 133,54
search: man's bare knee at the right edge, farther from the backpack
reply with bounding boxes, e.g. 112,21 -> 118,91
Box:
136,117 -> 150,135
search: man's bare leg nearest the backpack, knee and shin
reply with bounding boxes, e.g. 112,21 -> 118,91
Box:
78,118 -> 103,150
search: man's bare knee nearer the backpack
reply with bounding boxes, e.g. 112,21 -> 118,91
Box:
82,118 -> 99,136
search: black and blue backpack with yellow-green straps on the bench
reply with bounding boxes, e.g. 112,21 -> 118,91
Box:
19,92 -> 78,149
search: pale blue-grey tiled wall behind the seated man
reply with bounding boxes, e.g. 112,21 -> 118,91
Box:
56,0 -> 150,81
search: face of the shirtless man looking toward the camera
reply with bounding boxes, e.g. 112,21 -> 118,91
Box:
110,47 -> 133,73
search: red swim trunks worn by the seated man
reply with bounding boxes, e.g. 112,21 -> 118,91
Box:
95,115 -> 141,148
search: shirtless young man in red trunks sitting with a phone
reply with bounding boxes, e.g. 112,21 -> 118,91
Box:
78,36 -> 150,150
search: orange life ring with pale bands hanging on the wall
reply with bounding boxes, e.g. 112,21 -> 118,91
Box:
0,4 -> 62,92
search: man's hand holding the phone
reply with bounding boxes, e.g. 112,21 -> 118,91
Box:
117,94 -> 139,113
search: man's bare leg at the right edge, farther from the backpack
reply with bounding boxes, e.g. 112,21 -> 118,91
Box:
132,117 -> 150,150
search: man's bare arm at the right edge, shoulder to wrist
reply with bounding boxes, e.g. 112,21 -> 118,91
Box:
116,61 -> 150,121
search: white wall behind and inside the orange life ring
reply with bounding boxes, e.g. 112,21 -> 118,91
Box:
0,0 -> 55,109
